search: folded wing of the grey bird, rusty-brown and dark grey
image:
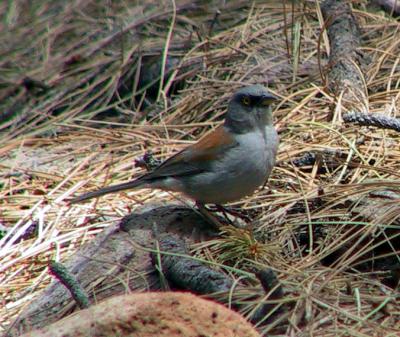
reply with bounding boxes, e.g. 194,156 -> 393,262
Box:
143,126 -> 238,180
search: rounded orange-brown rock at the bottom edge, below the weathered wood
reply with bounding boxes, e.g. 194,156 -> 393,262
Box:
22,292 -> 260,337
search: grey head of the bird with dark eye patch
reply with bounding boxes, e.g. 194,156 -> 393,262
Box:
225,84 -> 277,133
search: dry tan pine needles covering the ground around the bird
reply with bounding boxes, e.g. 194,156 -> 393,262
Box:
0,0 -> 400,336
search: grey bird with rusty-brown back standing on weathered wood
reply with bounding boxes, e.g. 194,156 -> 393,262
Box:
70,84 -> 279,226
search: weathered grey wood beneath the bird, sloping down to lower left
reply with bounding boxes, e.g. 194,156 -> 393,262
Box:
6,205 -> 216,336
